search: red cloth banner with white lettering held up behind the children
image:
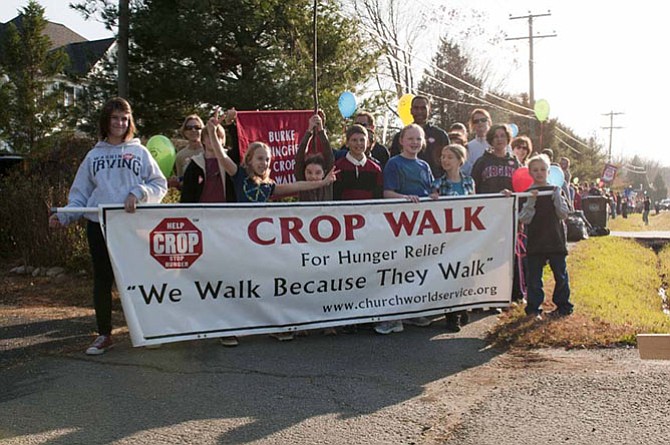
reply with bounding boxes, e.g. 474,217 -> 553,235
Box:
237,110 -> 314,184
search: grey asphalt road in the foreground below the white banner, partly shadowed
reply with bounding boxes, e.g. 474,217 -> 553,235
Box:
0,316 -> 670,445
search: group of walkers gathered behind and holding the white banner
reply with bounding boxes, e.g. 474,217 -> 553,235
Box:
50,96 -> 572,355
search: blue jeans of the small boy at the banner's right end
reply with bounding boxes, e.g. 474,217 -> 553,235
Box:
526,254 -> 573,315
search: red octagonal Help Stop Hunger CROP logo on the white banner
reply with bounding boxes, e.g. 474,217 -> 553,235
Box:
149,218 -> 202,269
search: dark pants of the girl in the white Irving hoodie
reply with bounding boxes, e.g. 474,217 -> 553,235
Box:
86,221 -> 114,335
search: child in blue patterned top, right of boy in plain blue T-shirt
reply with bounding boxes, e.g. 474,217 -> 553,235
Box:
430,144 -> 475,332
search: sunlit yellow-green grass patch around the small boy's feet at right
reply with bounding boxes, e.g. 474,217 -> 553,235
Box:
490,237 -> 670,348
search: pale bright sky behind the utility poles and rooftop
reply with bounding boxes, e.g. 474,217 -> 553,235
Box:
0,0 -> 670,167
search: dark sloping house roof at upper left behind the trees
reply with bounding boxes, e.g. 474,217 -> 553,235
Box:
0,15 -> 114,75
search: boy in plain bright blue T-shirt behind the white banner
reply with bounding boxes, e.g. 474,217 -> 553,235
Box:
375,124 -> 434,335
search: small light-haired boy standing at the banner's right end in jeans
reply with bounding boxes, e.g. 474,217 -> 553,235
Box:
519,154 -> 573,320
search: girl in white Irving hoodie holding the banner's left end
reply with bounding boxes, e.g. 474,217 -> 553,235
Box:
49,97 -> 167,355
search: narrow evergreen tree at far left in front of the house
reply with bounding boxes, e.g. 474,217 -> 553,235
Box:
0,0 -> 68,153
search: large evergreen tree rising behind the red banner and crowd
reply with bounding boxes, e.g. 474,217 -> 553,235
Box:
75,0 -> 375,135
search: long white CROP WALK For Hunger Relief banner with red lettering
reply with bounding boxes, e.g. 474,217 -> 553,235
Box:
101,195 -> 515,346
